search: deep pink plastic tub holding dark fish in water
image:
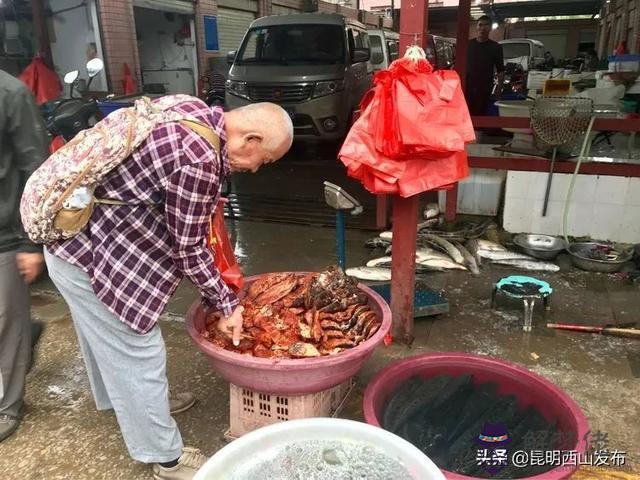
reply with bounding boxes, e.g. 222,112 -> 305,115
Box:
364,353 -> 589,480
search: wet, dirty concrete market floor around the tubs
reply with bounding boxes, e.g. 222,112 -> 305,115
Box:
0,222 -> 640,480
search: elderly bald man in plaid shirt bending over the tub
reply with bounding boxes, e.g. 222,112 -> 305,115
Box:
45,98 -> 293,480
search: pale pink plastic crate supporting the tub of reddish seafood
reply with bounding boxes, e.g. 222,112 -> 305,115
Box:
225,379 -> 354,440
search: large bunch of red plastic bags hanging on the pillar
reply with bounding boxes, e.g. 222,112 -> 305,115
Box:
338,55 -> 475,197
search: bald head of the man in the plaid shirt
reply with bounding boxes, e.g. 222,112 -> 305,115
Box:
225,103 -> 293,172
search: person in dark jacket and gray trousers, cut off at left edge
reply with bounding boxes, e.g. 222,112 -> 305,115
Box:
0,70 -> 47,442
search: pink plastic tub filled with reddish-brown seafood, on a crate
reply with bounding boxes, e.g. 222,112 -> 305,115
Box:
186,272 -> 391,395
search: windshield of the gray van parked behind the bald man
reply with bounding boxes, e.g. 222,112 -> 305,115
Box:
238,25 -> 345,65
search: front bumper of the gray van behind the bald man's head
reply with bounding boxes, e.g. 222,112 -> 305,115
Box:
226,92 -> 353,140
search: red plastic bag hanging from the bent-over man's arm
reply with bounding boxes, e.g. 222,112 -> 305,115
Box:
207,200 -> 244,293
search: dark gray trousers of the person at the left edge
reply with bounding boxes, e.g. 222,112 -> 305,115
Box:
0,251 -> 31,417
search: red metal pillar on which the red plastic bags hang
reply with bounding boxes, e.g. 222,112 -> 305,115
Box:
391,0 -> 429,344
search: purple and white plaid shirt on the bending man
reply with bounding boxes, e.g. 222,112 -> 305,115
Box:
48,101 -> 238,333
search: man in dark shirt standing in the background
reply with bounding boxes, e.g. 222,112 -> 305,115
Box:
465,15 -> 504,115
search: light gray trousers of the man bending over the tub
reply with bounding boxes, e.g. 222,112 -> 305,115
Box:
45,249 -> 182,463
